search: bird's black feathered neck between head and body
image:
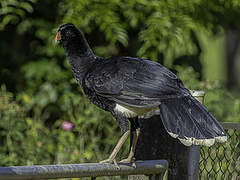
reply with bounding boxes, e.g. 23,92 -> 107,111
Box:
63,35 -> 97,85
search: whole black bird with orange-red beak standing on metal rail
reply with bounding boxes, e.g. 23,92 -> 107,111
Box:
56,23 -> 227,164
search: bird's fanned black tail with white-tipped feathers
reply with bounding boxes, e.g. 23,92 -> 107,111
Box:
159,95 -> 227,146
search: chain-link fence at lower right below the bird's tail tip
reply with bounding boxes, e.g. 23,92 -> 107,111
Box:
199,123 -> 240,180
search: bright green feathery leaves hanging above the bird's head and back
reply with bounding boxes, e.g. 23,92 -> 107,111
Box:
62,0 -> 198,65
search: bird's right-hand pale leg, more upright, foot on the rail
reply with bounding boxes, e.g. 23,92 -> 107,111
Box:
120,128 -> 140,167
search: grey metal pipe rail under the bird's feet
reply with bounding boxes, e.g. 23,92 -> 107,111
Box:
0,160 -> 168,180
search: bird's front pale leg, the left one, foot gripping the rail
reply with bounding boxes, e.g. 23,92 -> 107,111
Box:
100,130 -> 129,167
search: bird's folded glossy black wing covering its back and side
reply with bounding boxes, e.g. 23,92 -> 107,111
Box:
85,57 -> 188,107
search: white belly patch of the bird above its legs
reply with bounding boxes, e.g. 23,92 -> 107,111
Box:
114,104 -> 159,118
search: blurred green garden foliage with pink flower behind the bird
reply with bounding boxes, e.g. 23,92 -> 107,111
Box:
0,0 -> 240,166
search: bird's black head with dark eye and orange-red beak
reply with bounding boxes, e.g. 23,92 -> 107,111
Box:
55,23 -> 80,44
